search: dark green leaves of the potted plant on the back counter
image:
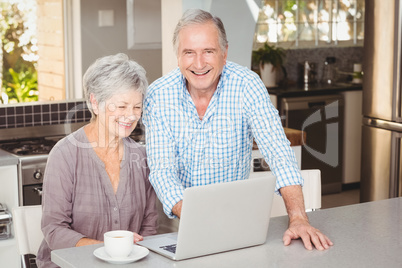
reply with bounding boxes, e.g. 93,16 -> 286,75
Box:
252,43 -> 285,68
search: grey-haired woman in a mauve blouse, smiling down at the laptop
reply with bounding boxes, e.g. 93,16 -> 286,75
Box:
36,54 -> 157,267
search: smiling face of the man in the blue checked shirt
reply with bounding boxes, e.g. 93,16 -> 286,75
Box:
177,22 -> 227,95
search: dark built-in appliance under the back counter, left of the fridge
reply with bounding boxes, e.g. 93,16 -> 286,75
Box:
280,94 -> 344,194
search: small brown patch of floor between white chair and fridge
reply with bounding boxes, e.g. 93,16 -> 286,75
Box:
321,189 -> 360,209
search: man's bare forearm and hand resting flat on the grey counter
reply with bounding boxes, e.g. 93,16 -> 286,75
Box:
279,185 -> 333,250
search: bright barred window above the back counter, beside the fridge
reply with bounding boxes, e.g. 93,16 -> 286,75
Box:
254,0 -> 365,48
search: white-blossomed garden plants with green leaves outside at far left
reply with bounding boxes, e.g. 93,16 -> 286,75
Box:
0,0 -> 38,103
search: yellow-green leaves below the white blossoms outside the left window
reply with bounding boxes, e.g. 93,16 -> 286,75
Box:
3,68 -> 38,102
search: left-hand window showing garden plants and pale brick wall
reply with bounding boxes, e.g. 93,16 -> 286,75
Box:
0,0 -> 82,104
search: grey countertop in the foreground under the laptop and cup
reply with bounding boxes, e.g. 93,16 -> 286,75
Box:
52,197 -> 402,268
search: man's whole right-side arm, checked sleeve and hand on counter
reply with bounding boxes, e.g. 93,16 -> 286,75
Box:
244,76 -> 332,250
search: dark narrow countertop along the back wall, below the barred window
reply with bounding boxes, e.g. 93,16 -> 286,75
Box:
268,83 -> 363,98
